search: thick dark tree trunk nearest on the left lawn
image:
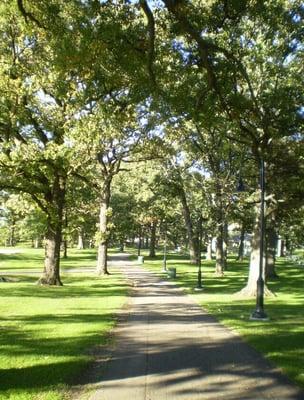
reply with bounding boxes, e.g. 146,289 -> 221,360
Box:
38,176 -> 66,286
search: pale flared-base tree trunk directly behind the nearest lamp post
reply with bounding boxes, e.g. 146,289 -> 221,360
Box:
237,206 -> 272,297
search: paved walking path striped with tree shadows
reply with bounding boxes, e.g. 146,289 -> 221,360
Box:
79,255 -> 304,400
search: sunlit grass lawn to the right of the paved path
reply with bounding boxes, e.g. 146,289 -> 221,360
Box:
134,248 -> 304,387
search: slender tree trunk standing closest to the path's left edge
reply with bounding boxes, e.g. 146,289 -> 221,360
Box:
96,181 -> 111,275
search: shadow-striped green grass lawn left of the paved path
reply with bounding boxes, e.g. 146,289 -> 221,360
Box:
0,249 -> 128,400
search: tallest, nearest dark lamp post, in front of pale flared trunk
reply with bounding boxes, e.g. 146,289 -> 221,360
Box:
250,156 -> 269,321
